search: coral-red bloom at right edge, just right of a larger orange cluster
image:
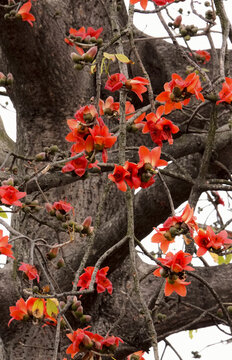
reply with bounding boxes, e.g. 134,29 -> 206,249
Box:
194,226 -> 232,256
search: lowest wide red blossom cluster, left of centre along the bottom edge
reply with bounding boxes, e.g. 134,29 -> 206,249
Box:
66,326 -> 123,358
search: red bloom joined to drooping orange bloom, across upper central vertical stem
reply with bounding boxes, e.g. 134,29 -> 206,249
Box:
105,73 -> 149,101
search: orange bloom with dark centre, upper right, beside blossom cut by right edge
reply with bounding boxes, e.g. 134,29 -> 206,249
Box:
156,73 -> 205,114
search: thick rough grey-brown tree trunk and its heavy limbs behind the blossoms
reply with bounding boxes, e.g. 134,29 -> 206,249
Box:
0,0 -> 232,360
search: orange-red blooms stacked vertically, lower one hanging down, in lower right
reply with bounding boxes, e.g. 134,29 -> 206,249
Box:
153,250 -> 194,296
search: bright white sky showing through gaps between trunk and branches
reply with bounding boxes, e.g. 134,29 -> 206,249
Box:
0,0 -> 232,360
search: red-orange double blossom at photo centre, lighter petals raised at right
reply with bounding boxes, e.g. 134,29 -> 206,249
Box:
108,146 -> 167,192
